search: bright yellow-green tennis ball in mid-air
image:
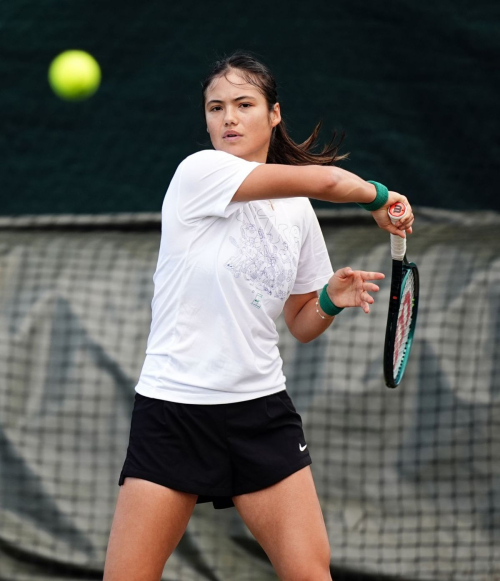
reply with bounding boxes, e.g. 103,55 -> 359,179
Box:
49,50 -> 101,101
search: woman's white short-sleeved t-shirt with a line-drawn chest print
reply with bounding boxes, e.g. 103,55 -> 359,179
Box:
135,150 -> 333,404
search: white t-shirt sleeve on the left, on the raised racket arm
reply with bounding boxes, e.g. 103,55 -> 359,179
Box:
177,149 -> 261,222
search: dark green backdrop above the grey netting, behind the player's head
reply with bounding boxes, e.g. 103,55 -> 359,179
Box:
0,0 -> 500,215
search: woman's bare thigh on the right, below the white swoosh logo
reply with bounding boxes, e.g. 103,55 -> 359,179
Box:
233,466 -> 331,581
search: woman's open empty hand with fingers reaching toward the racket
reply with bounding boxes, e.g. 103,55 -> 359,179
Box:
326,266 -> 385,314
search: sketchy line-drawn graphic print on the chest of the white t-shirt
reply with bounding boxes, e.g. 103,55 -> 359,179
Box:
225,204 -> 300,301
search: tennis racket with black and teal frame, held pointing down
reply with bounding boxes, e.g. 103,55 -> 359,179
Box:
384,202 -> 419,387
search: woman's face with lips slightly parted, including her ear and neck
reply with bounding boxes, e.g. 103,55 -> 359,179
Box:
205,70 -> 281,163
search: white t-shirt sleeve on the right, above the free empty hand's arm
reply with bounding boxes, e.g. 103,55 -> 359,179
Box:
291,198 -> 333,295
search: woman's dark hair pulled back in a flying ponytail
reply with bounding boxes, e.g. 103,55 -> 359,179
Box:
201,51 -> 349,165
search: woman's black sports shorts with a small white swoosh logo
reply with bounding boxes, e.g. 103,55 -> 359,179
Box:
118,390 -> 312,508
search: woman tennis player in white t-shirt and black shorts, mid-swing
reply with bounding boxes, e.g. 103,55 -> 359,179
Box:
104,52 -> 413,581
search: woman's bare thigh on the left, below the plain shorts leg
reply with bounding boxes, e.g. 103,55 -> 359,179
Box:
103,477 -> 198,581
